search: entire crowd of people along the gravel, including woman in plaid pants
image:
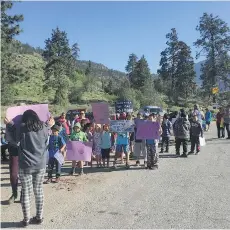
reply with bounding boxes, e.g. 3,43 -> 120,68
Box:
1,105 -> 230,226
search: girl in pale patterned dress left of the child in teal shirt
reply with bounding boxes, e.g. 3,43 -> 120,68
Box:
93,124 -> 101,168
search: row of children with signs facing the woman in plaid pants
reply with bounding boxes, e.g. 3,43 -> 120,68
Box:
45,108 -> 203,183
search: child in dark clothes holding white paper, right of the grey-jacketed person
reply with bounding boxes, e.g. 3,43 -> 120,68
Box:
189,114 -> 203,154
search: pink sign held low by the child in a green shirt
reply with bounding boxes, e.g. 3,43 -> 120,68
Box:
66,141 -> 93,161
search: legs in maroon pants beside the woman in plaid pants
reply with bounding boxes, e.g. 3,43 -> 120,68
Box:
9,155 -> 18,202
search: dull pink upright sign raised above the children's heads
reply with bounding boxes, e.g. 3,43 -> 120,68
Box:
92,102 -> 109,124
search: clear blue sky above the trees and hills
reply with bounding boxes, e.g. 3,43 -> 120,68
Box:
10,1 -> 230,73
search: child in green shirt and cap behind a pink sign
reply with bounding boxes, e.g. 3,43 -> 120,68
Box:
70,123 -> 88,175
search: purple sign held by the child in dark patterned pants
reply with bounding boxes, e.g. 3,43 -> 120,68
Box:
136,120 -> 160,140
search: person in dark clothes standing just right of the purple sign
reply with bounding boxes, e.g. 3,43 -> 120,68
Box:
160,114 -> 172,153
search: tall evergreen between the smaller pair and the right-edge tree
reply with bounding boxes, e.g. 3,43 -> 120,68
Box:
158,28 -> 195,102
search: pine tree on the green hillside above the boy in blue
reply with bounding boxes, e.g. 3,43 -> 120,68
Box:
43,28 -> 73,105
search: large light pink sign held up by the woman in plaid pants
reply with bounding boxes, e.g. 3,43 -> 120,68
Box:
6,104 -> 50,125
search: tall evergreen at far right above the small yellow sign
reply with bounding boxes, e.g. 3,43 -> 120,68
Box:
194,13 -> 230,93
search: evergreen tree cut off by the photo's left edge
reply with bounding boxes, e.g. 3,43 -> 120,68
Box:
1,1 -> 23,105
